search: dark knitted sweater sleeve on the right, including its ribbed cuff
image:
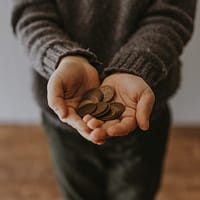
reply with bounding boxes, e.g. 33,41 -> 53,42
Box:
104,0 -> 196,88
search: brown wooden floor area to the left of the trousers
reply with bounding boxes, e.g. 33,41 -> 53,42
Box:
0,126 -> 62,200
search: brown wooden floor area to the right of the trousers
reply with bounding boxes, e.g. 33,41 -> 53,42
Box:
157,127 -> 200,200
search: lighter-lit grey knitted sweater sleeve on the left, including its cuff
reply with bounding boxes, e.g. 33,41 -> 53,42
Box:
11,0 -> 100,79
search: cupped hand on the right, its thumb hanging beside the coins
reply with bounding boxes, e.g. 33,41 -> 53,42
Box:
83,73 -> 155,144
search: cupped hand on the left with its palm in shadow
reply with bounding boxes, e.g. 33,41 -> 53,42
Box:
47,56 -> 99,139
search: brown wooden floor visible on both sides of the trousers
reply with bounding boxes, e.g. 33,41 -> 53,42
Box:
0,126 -> 200,200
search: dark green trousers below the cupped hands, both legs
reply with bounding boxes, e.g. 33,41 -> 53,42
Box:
43,107 -> 170,200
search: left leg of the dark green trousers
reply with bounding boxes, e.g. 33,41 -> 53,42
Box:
43,114 -> 106,200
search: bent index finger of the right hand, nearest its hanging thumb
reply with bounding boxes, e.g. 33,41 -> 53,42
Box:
107,117 -> 136,137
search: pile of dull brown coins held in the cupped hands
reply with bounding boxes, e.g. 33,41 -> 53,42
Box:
77,86 -> 125,121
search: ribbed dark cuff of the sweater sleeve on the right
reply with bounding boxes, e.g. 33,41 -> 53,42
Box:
104,50 -> 167,88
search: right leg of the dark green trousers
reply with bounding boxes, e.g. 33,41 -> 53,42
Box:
107,105 -> 170,200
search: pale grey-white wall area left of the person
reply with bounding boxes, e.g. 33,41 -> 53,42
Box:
0,0 -> 39,123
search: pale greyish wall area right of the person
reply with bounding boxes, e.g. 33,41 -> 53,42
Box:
171,1 -> 200,125
